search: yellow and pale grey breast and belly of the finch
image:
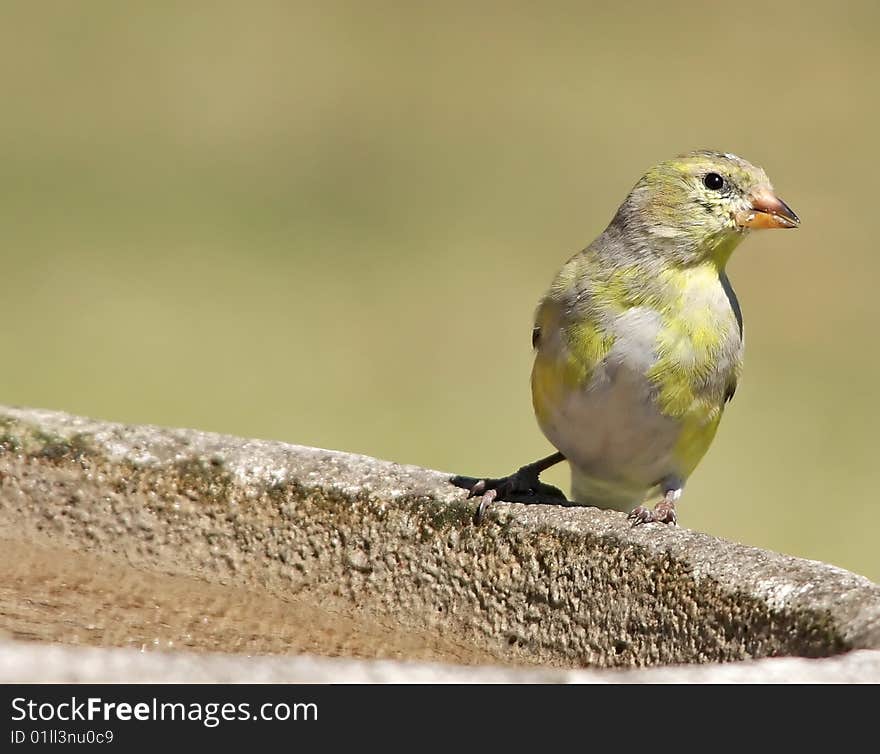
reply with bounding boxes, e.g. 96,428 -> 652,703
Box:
532,262 -> 742,486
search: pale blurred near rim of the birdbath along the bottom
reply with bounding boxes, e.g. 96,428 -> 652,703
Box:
0,642 -> 880,683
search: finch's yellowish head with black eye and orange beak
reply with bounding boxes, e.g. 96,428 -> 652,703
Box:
612,150 -> 800,266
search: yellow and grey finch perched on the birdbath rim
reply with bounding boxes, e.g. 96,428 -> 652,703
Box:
452,150 -> 800,526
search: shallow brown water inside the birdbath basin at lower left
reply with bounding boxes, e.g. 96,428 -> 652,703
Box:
0,532 -> 498,665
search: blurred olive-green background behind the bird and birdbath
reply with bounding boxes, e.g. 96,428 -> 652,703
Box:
0,0 -> 880,580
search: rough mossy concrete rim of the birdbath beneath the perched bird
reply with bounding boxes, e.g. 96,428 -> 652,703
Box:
0,408 -> 880,667
